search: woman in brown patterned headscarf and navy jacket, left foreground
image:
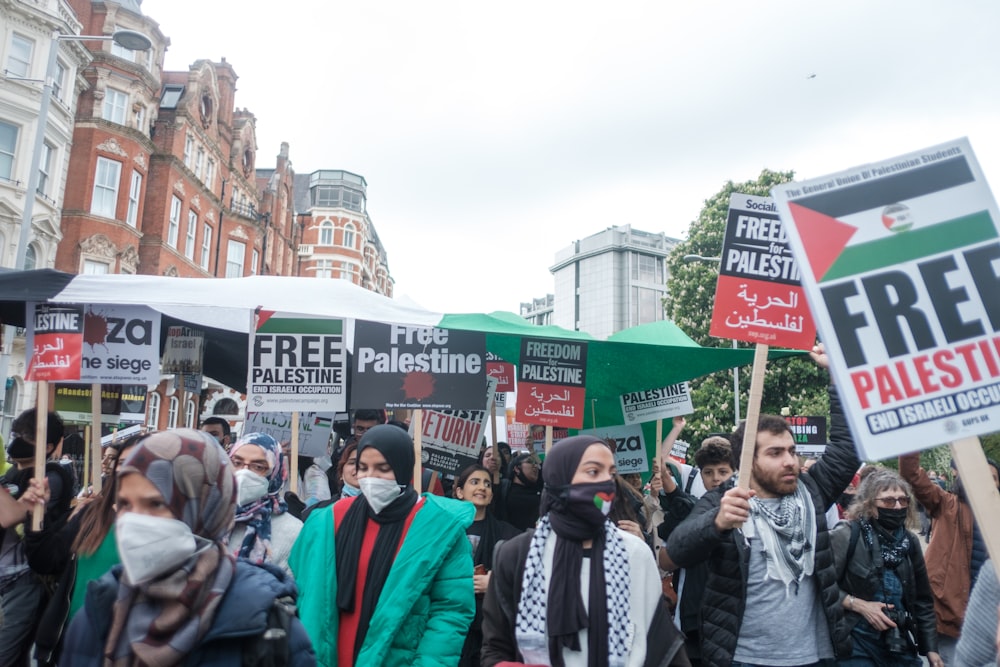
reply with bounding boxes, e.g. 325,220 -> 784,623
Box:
60,429 -> 315,667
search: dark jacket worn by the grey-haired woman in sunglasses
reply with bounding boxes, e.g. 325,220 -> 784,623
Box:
830,521 -> 938,655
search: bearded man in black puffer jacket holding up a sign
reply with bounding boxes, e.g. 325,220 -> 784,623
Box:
667,346 -> 859,667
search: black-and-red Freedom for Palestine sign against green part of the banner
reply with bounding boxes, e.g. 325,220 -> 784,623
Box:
517,338 -> 587,428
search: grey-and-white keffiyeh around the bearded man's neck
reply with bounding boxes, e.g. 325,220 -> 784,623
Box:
750,483 -> 816,593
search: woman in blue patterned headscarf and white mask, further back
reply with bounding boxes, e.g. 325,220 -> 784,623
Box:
228,433 -> 302,574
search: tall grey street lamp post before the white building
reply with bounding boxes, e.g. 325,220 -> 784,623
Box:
14,30 -> 153,271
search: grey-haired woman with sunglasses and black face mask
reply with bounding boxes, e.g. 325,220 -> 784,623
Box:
831,470 -> 944,667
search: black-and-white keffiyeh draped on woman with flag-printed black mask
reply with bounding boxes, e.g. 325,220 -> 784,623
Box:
515,515 -> 631,667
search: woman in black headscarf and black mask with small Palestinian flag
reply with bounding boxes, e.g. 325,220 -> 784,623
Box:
480,435 -> 690,667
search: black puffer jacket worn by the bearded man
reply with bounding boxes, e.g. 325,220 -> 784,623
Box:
667,387 -> 861,667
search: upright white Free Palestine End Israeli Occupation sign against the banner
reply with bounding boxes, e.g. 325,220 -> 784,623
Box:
247,311 -> 347,412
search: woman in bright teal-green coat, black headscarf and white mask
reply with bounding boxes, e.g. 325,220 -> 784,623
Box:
290,424 -> 475,667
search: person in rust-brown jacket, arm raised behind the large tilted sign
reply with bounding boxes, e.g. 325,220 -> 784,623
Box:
899,454 -> 1000,665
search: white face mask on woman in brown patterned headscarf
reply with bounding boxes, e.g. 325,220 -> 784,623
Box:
115,512 -> 197,585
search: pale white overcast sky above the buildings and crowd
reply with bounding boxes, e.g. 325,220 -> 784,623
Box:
142,0 -> 1000,312
